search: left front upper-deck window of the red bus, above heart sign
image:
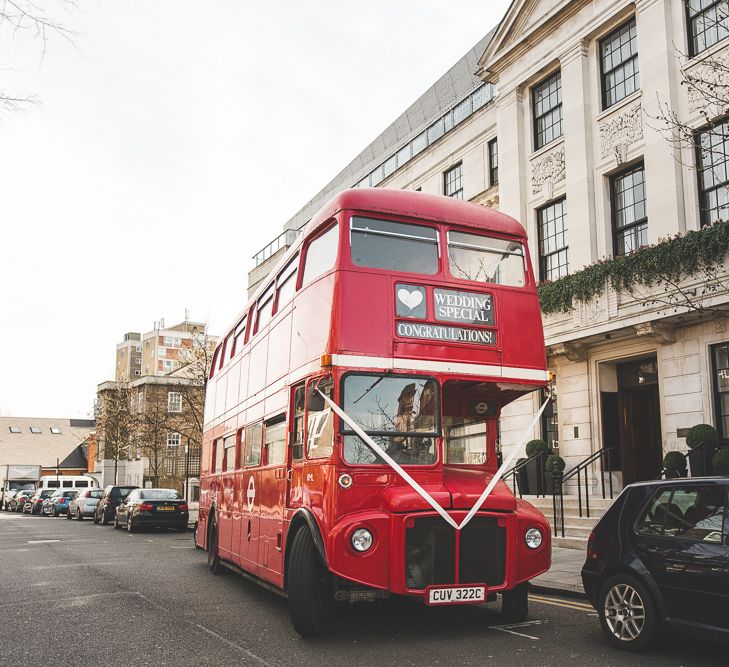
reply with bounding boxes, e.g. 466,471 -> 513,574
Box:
350,216 -> 438,275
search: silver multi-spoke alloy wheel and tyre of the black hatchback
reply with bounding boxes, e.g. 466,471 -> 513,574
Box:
597,573 -> 660,651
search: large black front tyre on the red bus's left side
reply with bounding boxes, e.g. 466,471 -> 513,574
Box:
288,528 -> 334,637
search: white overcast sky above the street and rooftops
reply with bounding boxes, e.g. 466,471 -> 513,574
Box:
0,0 -> 509,417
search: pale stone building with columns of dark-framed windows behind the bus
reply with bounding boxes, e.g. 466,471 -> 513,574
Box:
250,0 -> 729,485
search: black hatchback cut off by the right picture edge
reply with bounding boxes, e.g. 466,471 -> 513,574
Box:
582,477 -> 729,651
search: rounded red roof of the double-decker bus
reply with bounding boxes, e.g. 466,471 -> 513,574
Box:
303,188 -> 526,238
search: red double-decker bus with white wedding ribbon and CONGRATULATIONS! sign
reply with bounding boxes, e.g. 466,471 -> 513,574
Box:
195,189 -> 551,636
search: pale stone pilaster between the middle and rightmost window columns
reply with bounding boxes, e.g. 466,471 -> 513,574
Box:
636,0 -> 684,237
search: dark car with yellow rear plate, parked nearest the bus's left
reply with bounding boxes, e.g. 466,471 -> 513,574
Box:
114,489 -> 188,533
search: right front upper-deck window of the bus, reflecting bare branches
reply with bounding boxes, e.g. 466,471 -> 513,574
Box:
448,231 -> 525,287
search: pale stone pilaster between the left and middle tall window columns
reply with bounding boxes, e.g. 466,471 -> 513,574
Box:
560,40 -> 598,272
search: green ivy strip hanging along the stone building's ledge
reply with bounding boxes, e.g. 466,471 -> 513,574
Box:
538,222 -> 729,314
